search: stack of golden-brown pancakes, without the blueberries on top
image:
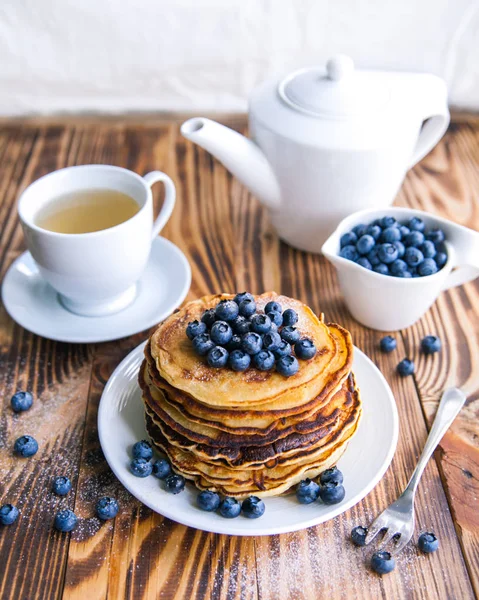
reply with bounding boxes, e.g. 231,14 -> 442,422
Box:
139,293 -> 361,499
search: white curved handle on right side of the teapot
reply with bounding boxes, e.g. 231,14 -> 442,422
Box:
408,75 -> 450,169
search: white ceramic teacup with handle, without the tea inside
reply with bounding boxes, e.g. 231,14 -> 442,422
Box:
18,165 -> 176,317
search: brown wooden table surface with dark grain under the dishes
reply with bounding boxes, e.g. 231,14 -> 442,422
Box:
0,119 -> 479,600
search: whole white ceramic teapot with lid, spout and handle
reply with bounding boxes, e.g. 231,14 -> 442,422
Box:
181,55 -> 449,252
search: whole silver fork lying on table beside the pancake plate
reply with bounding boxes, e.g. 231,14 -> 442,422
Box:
365,388 -> 466,554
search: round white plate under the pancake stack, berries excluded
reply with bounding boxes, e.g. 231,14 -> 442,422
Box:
98,344 -> 398,535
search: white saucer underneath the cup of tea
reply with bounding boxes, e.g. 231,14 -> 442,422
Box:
2,237 -> 191,343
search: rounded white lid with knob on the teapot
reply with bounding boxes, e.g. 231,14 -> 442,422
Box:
278,54 -> 389,118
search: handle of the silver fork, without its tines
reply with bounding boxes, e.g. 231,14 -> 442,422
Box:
404,388 -> 466,496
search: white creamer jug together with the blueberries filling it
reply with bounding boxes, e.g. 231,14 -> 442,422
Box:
322,208 -> 479,331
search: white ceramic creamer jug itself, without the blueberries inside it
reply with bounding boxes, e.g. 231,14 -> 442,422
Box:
322,208 -> 479,331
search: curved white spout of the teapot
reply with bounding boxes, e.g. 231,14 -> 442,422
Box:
181,117 -> 280,210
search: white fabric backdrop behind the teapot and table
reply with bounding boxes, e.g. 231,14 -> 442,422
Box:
0,0 -> 479,115
